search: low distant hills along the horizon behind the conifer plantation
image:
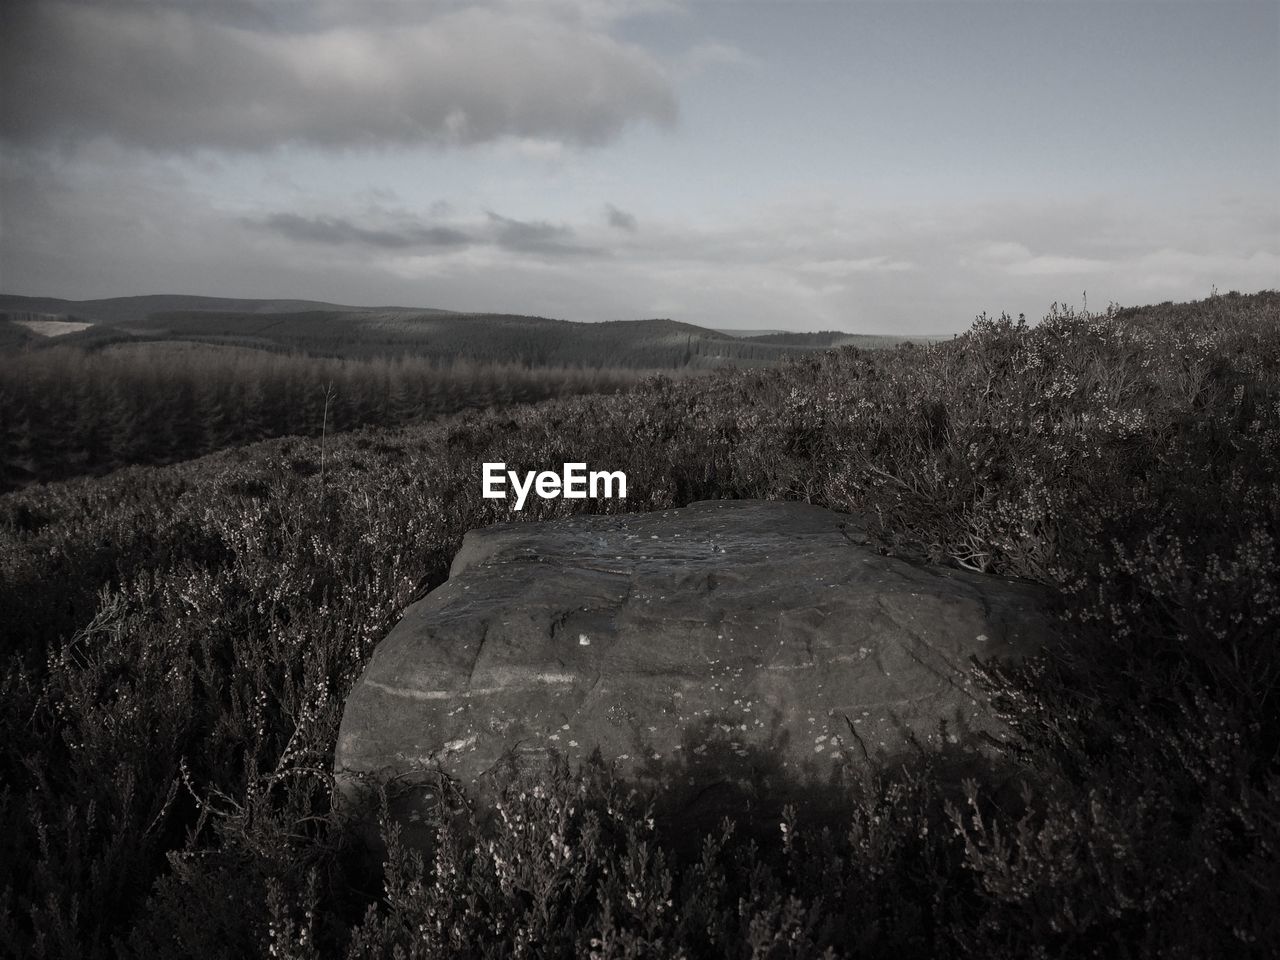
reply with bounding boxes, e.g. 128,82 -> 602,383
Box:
0,296 -> 936,370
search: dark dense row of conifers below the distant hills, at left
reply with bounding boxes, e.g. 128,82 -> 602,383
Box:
0,344 -> 643,492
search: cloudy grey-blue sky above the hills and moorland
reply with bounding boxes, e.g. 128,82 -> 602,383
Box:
0,0 -> 1280,334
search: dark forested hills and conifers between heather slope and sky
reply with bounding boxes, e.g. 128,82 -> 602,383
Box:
0,294 -> 931,493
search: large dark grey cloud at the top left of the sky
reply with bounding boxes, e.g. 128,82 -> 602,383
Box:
0,0 -> 677,151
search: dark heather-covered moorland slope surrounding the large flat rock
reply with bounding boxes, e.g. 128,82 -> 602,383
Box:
0,292 -> 1280,960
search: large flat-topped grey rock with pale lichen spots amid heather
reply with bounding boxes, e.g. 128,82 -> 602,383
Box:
335,500 -> 1051,829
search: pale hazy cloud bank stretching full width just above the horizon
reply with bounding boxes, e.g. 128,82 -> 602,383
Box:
0,143 -> 1280,333
